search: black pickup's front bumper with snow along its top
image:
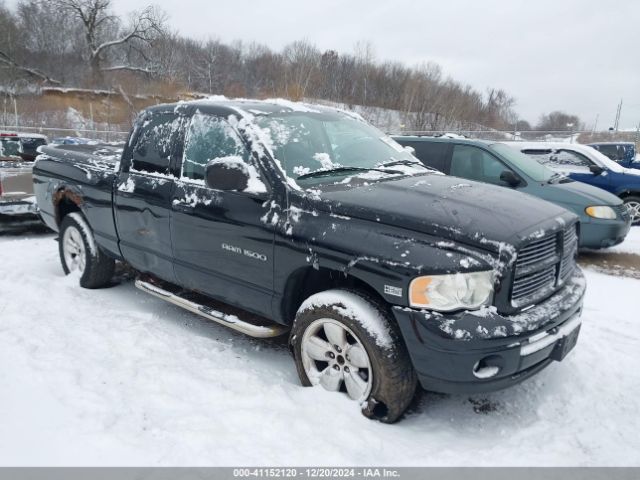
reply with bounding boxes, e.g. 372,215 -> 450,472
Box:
393,269 -> 586,393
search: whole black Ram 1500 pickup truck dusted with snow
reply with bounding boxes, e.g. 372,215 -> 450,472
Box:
34,100 -> 585,422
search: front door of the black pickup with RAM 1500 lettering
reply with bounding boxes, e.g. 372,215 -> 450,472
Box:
171,113 -> 274,314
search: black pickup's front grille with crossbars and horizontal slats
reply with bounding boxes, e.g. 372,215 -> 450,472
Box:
511,225 -> 578,308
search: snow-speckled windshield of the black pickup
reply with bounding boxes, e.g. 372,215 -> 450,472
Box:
256,111 -> 430,185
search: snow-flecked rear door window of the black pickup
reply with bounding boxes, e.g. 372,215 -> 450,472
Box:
131,113 -> 180,175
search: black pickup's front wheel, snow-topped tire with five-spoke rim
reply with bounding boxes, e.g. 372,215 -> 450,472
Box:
289,290 -> 417,423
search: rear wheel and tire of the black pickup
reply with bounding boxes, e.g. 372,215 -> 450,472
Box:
58,212 -> 116,288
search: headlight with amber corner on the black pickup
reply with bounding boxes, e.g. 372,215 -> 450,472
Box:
409,270 -> 493,312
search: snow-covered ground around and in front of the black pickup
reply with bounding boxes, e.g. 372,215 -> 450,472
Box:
0,229 -> 640,466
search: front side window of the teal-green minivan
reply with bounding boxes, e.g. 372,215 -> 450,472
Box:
450,145 -> 509,186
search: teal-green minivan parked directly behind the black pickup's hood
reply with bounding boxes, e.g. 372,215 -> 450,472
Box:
394,136 -> 630,248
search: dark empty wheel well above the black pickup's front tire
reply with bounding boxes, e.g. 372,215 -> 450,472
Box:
282,267 -> 386,324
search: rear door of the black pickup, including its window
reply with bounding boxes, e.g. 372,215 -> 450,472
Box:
114,113 -> 181,282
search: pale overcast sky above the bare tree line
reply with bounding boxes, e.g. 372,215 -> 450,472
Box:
9,0 -> 640,128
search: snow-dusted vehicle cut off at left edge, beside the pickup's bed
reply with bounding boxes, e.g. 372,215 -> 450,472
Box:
0,132 -> 47,215
